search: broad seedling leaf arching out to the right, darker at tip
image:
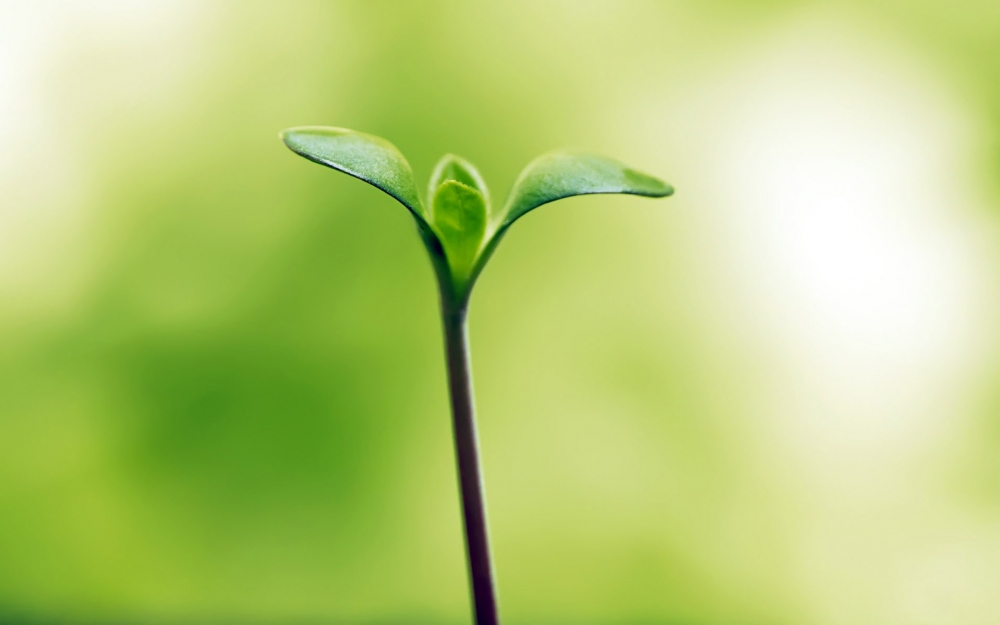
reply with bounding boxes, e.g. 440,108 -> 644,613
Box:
499,152 -> 674,230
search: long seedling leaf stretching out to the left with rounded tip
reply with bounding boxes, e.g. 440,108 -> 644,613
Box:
281,126 -> 427,224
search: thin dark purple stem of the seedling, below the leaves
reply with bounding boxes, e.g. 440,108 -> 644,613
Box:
441,298 -> 500,625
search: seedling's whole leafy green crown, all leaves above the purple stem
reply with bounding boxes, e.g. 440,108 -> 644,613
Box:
281,126 -> 673,303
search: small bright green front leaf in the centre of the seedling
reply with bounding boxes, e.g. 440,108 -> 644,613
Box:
433,180 -> 487,288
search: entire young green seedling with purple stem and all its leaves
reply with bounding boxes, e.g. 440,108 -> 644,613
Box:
281,126 -> 673,625
